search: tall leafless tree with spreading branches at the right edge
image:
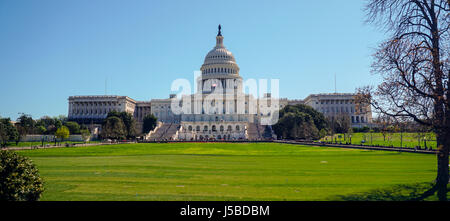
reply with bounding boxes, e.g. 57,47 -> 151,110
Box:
358,0 -> 450,200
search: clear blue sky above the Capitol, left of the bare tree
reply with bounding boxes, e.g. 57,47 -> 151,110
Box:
0,0 -> 385,120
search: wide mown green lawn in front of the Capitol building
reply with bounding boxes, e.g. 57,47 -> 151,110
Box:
18,143 -> 444,201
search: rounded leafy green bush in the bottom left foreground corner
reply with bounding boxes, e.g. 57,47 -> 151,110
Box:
0,150 -> 44,201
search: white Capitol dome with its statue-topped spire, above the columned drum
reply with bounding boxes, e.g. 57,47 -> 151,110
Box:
200,25 -> 239,76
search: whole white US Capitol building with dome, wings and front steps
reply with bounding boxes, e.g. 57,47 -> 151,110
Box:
68,25 -> 372,140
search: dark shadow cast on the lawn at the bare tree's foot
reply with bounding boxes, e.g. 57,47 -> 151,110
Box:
336,182 -> 449,201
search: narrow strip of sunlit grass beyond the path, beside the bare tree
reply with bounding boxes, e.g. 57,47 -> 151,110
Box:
321,132 -> 436,149
